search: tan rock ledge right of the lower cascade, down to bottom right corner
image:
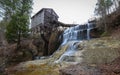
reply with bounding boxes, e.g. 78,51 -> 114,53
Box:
59,37 -> 120,75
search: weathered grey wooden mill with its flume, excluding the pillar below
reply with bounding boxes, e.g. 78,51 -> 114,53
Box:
31,8 -> 74,34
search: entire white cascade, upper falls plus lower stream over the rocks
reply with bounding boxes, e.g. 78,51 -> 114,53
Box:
55,23 -> 94,63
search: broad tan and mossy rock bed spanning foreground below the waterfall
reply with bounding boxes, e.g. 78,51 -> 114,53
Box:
6,37 -> 120,75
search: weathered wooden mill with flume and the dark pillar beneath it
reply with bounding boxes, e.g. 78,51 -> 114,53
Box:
31,8 -> 74,55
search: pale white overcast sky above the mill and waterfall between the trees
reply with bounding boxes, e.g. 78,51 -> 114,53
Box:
32,0 -> 97,24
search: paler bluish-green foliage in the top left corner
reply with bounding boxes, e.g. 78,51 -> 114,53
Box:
0,0 -> 19,21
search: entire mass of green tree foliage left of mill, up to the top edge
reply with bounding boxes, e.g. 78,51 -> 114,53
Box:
0,0 -> 33,42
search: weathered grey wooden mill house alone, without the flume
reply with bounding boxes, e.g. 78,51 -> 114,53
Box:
31,8 -> 59,34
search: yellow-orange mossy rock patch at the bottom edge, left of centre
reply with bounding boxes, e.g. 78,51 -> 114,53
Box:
14,64 -> 59,75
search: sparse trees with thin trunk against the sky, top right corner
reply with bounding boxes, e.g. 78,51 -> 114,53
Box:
94,0 -> 120,32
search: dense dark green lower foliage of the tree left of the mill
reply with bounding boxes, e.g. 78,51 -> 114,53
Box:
6,13 -> 28,42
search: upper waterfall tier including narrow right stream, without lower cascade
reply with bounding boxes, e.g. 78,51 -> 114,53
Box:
62,23 -> 94,45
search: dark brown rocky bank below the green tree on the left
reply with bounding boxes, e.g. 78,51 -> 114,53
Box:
0,39 -> 38,73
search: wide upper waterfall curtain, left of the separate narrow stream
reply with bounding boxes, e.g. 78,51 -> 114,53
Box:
62,24 -> 87,45
